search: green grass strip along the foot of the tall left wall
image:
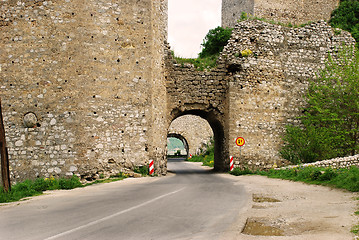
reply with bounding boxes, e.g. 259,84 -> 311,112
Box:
0,173 -> 127,203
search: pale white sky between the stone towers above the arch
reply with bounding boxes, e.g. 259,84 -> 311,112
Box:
168,0 -> 222,58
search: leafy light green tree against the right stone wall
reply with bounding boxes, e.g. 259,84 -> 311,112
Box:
281,47 -> 359,162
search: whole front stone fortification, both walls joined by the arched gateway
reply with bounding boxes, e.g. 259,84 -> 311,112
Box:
0,0 -> 354,184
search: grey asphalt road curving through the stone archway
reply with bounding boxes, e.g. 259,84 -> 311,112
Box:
0,159 -> 248,240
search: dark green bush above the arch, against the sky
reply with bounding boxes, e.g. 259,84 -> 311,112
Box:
199,27 -> 232,58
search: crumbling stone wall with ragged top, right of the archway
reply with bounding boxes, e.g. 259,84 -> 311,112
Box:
221,20 -> 354,168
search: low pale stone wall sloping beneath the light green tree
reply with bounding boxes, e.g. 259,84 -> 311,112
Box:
284,154 -> 359,169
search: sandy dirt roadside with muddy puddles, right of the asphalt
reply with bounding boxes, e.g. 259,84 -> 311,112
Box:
222,175 -> 359,240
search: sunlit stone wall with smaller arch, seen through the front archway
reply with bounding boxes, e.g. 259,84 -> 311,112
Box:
168,115 -> 213,155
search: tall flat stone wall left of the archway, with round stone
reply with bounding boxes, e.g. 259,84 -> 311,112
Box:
0,0 -> 167,180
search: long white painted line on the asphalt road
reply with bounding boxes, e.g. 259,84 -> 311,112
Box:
45,188 -> 185,240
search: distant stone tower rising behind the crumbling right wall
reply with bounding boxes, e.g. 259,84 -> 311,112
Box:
222,0 -> 339,27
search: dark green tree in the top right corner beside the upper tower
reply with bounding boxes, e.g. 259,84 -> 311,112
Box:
329,0 -> 359,42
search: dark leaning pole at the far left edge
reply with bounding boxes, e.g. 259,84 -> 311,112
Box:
0,98 -> 11,192
